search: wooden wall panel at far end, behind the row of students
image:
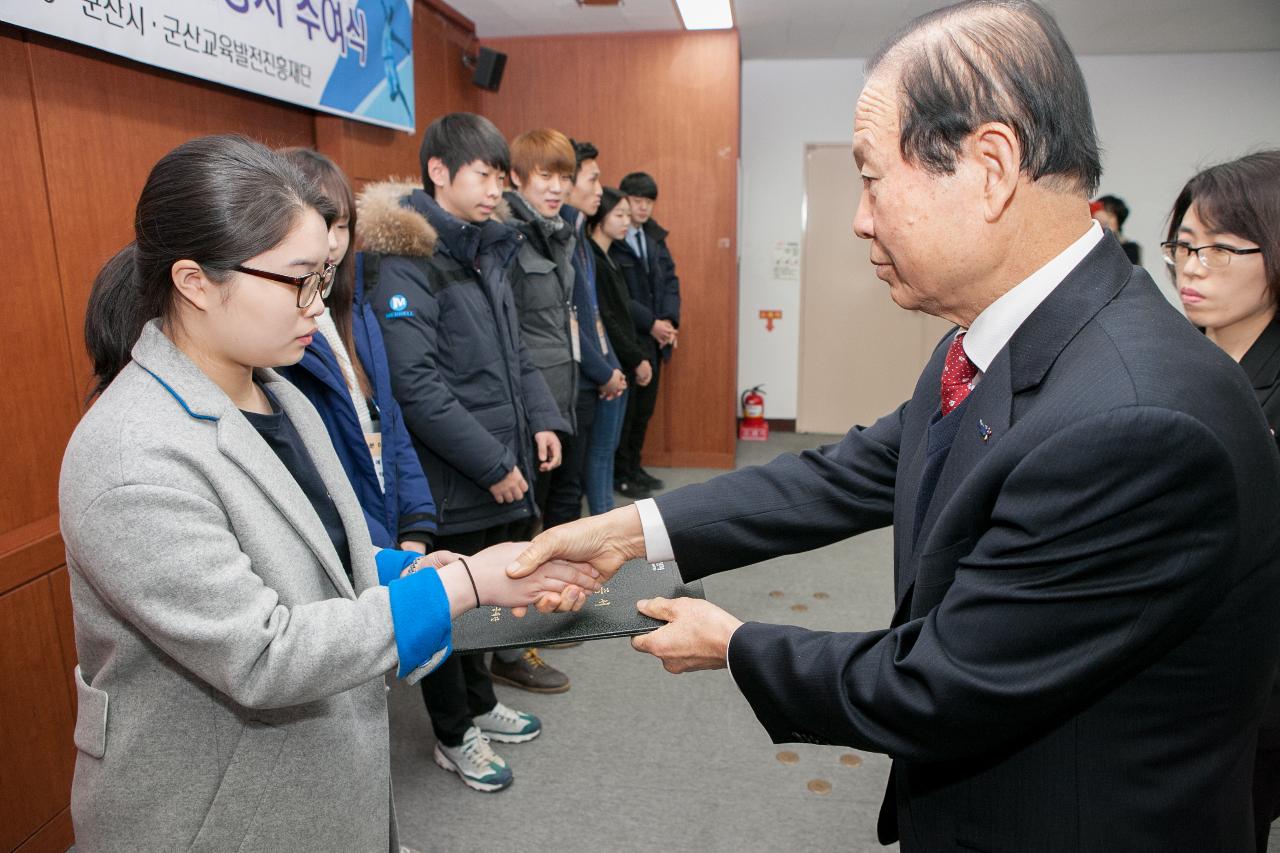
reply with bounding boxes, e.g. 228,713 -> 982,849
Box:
480,32 -> 740,467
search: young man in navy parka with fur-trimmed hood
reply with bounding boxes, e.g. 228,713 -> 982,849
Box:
358,113 -> 568,792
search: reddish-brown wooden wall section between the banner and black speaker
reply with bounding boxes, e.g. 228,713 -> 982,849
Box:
316,0 -> 480,184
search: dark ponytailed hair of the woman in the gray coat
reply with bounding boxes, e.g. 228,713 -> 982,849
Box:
84,136 -> 335,398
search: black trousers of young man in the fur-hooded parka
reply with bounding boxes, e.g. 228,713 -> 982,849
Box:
419,524 -> 513,747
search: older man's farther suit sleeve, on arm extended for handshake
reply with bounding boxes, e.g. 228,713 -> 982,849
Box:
657,403 -> 908,580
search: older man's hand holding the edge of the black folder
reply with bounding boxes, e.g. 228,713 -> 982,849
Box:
631,598 -> 742,672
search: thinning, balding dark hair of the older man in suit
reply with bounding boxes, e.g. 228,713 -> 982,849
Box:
867,0 -> 1102,197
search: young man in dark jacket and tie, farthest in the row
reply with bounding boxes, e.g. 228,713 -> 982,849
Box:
609,172 -> 680,498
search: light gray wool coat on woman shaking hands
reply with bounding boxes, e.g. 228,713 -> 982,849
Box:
59,321 -> 409,853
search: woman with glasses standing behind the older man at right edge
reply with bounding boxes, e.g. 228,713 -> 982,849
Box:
1161,150 -> 1280,850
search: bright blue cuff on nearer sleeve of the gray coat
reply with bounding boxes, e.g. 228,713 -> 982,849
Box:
387,569 -> 453,684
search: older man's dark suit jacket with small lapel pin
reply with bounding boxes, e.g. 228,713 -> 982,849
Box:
658,237 -> 1280,853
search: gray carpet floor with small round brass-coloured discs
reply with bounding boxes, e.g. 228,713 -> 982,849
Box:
389,433 -> 897,853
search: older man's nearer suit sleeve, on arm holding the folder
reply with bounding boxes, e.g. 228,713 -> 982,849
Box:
732,407 -> 1238,761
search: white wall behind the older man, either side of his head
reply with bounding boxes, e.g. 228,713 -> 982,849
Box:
737,51 -> 1280,418
